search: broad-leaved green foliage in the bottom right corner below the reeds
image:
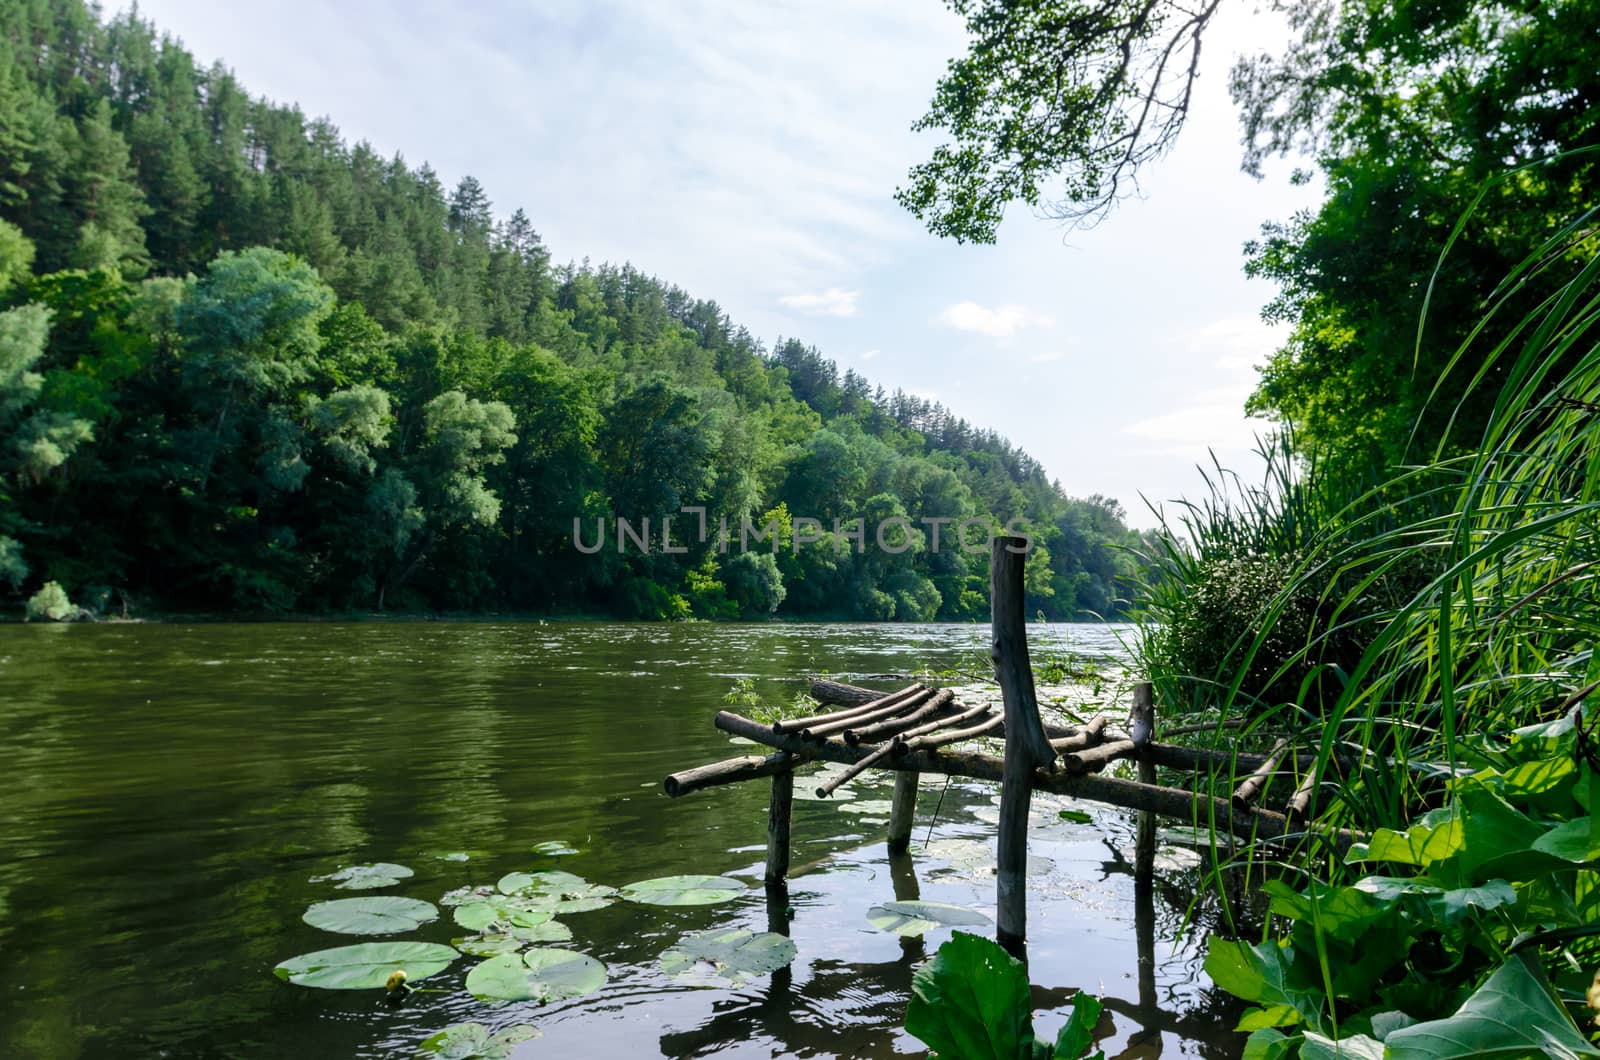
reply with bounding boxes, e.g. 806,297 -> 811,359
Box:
1206,726 -> 1600,1057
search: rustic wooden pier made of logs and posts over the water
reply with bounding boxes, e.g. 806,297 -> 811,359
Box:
662,538 -> 1360,953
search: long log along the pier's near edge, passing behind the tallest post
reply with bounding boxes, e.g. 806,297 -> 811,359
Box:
715,711 -> 1366,855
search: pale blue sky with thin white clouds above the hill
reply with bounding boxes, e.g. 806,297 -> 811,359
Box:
118,0 -> 1318,527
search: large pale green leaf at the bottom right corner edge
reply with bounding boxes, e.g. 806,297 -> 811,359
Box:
1384,954 -> 1600,1060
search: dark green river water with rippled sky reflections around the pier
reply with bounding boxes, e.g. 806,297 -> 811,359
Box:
0,623 -> 1242,1060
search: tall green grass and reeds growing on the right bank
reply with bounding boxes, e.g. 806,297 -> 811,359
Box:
1139,182 -> 1600,831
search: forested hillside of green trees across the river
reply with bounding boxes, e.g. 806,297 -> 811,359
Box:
0,0 -> 1136,620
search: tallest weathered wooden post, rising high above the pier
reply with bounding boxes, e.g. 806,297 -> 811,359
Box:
989,536 -> 1056,956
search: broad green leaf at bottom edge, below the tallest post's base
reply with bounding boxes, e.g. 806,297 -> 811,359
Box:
906,932 -> 1034,1060
